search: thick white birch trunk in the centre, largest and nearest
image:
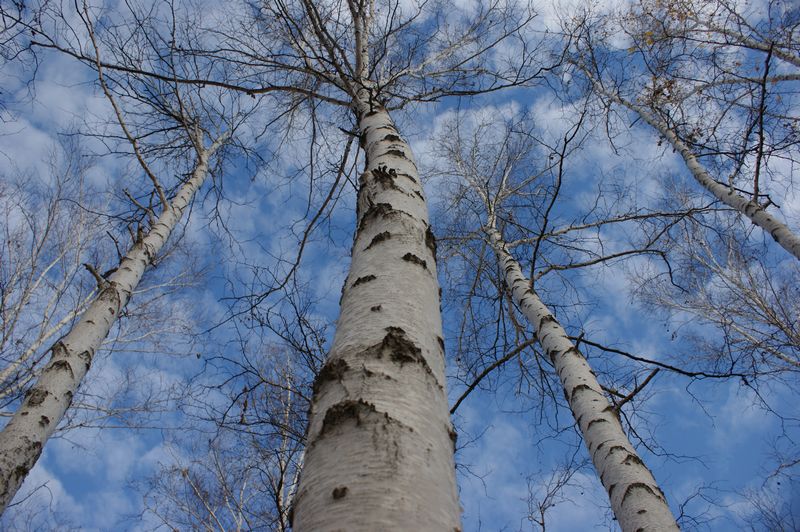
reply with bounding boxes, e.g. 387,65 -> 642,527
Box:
293,98 -> 460,532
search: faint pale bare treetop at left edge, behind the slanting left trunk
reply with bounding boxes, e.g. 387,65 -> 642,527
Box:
0,142 -> 107,404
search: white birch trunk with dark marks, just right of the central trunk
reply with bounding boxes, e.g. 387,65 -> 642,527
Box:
487,228 -> 678,532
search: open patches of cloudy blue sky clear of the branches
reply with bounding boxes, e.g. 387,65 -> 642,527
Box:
0,0 -> 800,531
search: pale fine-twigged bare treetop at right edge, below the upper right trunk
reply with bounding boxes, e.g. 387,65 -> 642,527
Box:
634,201 -> 800,378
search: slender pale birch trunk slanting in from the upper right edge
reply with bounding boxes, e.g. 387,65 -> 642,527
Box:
590,83 -> 800,260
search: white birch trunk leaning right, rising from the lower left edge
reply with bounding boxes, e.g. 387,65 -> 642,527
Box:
0,136 -> 226,512
